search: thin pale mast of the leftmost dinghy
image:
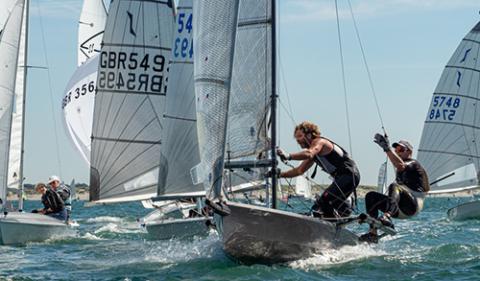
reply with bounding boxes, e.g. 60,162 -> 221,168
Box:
18,0 -> 30,211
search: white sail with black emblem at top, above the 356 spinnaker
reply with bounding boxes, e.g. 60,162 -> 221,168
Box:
78,0 -> 107,66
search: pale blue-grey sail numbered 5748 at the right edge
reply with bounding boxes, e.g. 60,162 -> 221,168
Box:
418,23 -> 480,192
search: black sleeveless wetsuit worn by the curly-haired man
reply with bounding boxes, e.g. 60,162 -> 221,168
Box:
312,138 -> 360,218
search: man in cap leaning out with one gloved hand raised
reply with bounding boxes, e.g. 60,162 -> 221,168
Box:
360,134 -> 430,243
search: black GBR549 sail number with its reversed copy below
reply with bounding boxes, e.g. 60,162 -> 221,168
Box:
97,49 -> 168,94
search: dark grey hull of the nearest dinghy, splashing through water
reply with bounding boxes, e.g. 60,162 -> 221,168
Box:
217,202 -> 359,264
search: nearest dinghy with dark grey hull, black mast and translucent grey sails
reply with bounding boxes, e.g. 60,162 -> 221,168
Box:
192,0 -> 368,264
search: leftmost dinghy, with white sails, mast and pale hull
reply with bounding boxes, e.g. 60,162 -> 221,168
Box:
0,0 -> 68,245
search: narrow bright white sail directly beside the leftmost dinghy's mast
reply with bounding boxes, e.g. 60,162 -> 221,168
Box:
7,0 -> 28,189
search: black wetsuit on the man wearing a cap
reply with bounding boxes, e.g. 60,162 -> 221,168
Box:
365,159 -> 430,219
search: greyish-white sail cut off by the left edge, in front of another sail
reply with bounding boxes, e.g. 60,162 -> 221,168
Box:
0,0 -> 25,202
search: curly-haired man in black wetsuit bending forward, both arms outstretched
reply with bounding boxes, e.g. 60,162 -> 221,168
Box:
277,121 -> 360,218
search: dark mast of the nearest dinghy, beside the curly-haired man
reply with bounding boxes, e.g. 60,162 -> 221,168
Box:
270,0 -> 278,209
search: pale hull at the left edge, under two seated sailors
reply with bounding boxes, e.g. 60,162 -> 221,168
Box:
0,212 -> 68,245
